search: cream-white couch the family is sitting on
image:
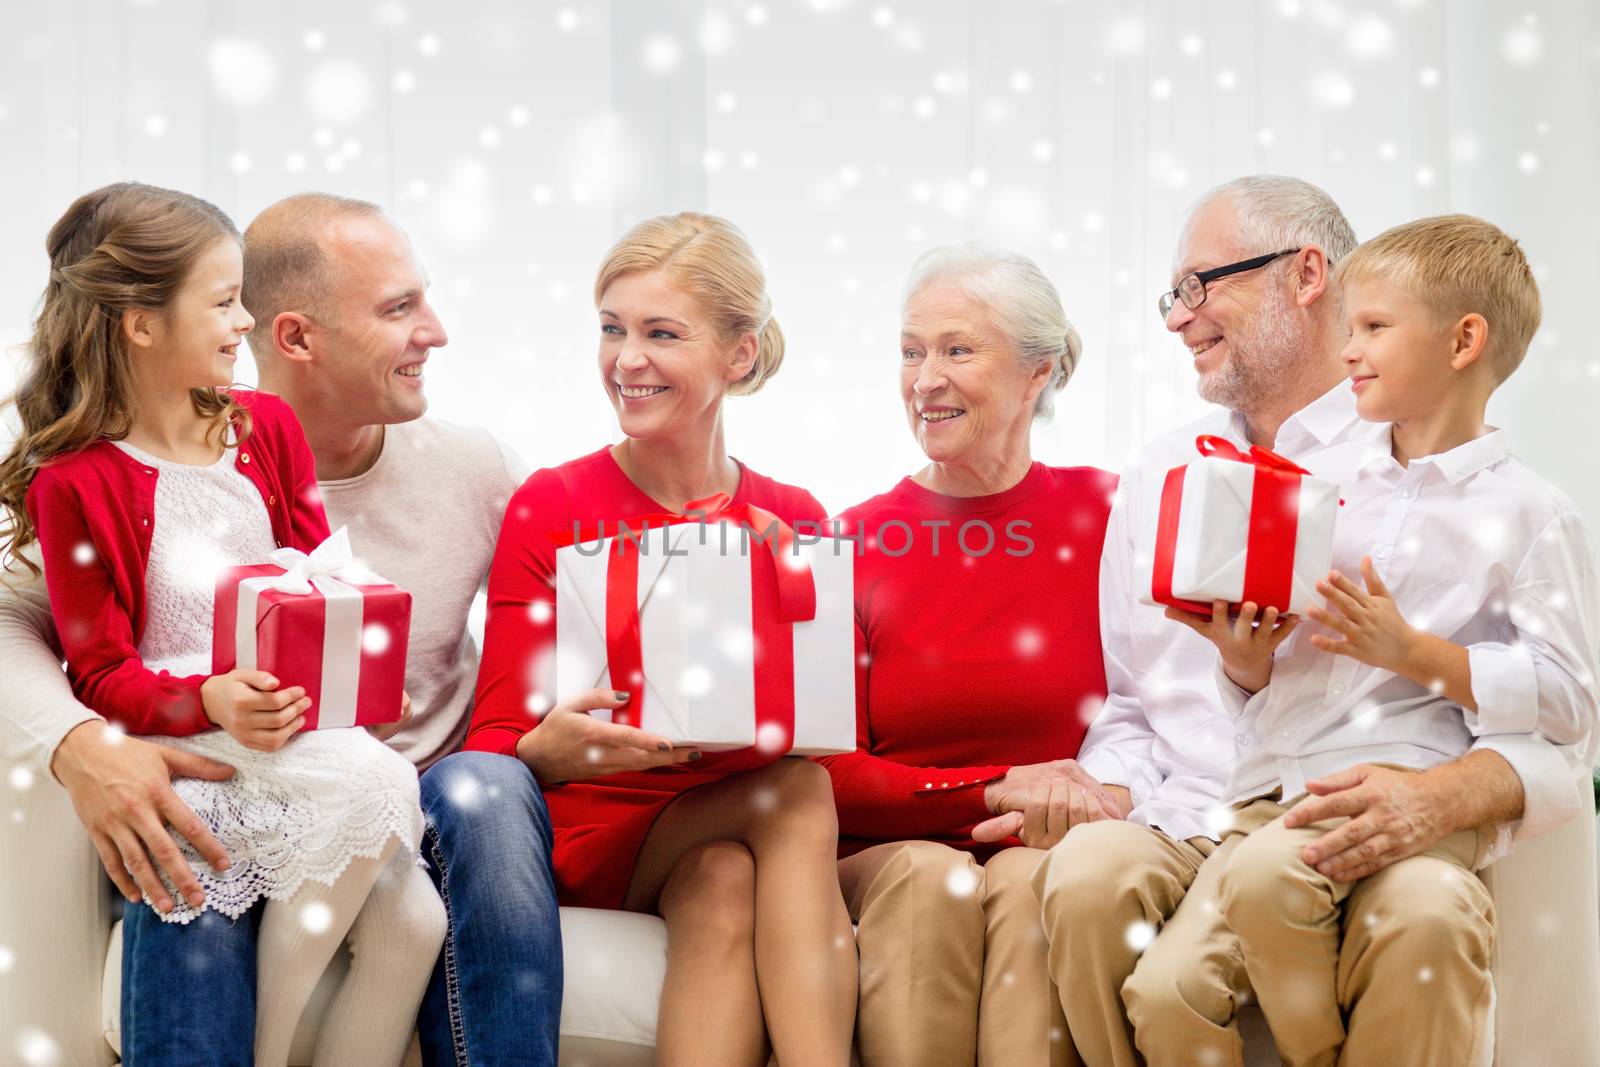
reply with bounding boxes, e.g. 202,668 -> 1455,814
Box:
0,758 -> 1600,1067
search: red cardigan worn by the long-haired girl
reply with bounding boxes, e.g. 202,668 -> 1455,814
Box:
27,389 -> 328,737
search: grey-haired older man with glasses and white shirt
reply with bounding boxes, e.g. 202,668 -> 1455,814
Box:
1034,176 -> 1581,1067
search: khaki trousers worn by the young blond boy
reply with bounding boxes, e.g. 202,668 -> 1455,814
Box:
1221,800 -> 1494,1067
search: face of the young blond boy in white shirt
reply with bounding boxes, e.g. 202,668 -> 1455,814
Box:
1339,280 -> 1454,422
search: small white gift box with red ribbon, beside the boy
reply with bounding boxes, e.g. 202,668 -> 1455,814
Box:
1141,434 -> 1339,616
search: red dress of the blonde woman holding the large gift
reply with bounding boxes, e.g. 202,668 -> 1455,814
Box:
466,446 -> 827,909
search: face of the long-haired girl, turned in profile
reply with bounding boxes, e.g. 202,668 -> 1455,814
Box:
144,237 -> 256,389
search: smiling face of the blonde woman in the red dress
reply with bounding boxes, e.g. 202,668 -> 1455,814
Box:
600,270 -> 757,438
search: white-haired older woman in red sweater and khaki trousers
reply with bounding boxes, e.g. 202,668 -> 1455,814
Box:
824,245 -> 1130,1067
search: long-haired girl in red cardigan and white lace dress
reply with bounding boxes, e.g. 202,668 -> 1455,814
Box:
0,182 -> 445,1067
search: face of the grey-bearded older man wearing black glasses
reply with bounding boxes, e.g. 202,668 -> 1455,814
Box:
1166,200 -> 1298,411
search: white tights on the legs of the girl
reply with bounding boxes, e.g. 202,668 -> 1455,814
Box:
256,838 -> 445,1067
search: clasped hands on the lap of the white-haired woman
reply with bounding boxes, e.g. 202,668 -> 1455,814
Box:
973,760 -> 1133,848
